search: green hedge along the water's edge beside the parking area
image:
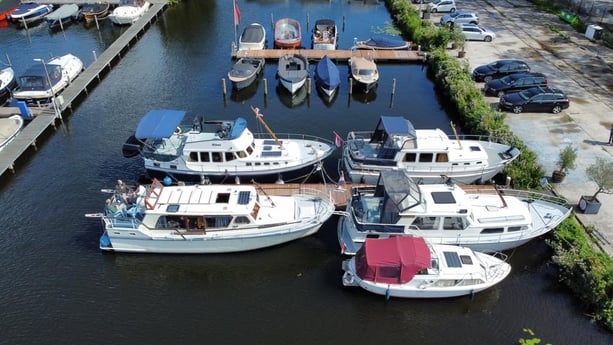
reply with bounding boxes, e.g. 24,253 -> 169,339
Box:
385,0 -> 613,331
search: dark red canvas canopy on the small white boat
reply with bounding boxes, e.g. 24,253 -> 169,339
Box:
355,236 -> 431,284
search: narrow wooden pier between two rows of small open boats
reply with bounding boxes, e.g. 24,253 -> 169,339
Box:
233,49 -> 427,62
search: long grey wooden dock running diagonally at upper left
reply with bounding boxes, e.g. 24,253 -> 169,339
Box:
0,1 -> 167,176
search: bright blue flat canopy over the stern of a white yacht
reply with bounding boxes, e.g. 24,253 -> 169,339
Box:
135,109 -> 185,139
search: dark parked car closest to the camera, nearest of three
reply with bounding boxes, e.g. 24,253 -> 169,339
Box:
498,86 -> 570,114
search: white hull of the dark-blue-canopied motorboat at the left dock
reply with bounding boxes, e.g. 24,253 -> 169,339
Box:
13,54 -> 84,103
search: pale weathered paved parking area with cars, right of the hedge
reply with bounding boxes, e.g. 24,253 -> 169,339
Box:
420,0 -> 613,256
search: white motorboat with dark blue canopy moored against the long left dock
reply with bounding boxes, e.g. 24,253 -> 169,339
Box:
13,54 -> 84,104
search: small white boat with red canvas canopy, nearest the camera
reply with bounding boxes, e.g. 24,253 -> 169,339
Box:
343,237 -> 511,298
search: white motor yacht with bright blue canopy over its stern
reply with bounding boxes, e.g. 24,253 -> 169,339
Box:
124,108 -> 336,182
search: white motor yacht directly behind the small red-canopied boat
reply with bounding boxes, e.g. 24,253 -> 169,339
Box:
338,170 -> 572,255
